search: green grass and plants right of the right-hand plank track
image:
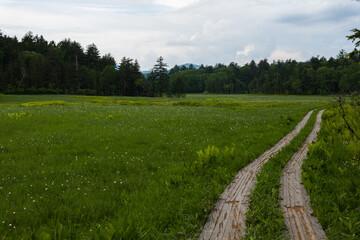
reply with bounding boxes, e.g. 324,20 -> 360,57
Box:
303,107 -> 360,239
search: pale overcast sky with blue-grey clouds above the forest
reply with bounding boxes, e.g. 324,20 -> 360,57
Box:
0,0 -> 360,70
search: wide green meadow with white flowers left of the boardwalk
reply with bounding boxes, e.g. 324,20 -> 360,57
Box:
0,94 -> 331,239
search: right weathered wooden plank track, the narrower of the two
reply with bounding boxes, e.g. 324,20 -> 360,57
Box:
280,111 -> 327,240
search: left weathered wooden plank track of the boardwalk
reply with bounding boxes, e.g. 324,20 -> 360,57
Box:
199,111 -> 313,240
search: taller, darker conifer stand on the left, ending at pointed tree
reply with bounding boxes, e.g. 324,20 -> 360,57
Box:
0,31 -> 182,96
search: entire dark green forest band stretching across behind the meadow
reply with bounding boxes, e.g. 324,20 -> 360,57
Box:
0,31 -> 360,96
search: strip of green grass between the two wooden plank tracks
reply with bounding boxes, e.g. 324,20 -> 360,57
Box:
244,111 -> 316,240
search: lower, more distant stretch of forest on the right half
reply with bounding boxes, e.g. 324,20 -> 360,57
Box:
170,50 -> 360,95
